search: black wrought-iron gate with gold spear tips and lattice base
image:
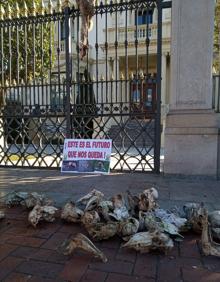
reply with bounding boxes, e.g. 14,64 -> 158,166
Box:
0,0 -> 163,172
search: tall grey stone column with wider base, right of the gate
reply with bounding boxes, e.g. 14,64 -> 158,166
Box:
164,0 -> 218,176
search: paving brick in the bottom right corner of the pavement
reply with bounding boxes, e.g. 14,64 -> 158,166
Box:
182,267 -> 220,282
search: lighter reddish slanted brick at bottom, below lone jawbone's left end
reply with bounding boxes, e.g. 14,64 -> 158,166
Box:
59,256 -> 91,282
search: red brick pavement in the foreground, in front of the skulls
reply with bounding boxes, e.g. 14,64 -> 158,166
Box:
0,205 -> 220,282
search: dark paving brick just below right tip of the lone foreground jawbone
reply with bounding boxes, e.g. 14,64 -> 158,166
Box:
89,260 -> 133,274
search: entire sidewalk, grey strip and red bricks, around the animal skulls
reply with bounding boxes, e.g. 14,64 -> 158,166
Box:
0,168 -> 220,282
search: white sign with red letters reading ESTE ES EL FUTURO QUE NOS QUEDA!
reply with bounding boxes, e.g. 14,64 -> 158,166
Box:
61,139 -> 112,173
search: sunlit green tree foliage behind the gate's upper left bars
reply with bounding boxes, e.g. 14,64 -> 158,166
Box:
0,0 -> 54,84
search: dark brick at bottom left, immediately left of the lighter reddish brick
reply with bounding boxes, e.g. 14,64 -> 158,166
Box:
17,260 -> 63,278
